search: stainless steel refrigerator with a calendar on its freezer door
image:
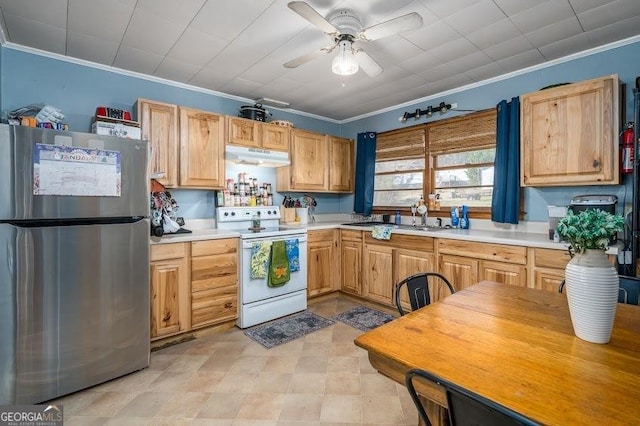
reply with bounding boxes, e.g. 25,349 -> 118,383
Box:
0,125 -> 150,405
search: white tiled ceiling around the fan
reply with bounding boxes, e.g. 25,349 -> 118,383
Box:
0,0 -> 640,120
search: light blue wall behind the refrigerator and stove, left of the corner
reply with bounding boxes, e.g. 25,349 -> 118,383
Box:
0,47 -> 352,219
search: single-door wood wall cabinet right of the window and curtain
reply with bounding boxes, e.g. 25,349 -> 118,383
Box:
520,75 -> 620,186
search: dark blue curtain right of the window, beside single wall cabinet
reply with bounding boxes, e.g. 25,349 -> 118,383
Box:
491,97 -> 520,224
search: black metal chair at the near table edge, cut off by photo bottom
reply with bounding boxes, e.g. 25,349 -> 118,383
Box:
405,369 -> 538,426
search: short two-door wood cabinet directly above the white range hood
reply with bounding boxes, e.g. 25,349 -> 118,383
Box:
227,117 -> 289,151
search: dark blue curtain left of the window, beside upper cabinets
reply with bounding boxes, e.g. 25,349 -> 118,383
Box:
353,132 -> 376,215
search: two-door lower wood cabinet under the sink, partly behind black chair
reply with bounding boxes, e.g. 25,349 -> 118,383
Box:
362,233 -> 436,306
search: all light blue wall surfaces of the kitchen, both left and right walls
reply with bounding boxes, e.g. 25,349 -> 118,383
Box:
0,42 -> 640,221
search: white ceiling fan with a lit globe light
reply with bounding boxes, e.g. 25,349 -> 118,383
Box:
284,1 -> 422,77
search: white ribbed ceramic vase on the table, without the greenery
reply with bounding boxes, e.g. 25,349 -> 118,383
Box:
565,250 -> 620,343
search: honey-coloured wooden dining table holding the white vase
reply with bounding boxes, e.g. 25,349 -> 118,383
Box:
355,281 -> 640,426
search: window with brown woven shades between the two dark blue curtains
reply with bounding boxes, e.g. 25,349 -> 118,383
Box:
373,108 -> 496,216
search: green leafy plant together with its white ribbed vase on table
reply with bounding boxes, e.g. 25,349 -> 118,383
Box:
556,209 -> 624,343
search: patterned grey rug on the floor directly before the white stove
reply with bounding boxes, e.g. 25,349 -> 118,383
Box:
244,311 -> 335,349
